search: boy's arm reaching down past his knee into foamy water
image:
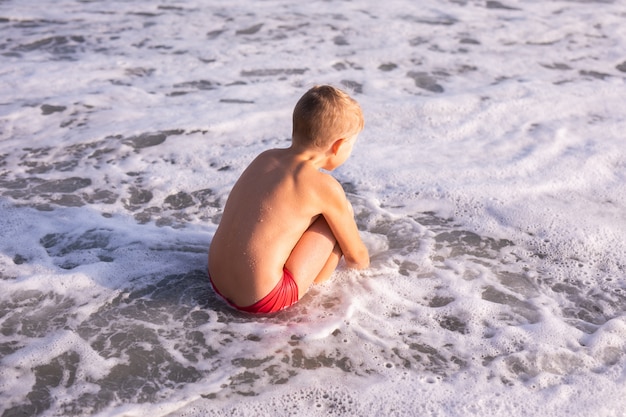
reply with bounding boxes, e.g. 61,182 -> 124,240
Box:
321,178 -> 370,269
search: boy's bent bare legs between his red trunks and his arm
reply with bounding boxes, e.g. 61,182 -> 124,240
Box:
285,216 -> 341,298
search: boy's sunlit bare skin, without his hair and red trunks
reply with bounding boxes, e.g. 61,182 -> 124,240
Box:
209,135 -> 369,306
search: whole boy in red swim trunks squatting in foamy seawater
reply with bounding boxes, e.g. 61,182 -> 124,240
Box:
209,86 -> 369,313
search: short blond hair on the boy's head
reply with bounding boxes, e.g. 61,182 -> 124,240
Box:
292,85 -> 364,148
